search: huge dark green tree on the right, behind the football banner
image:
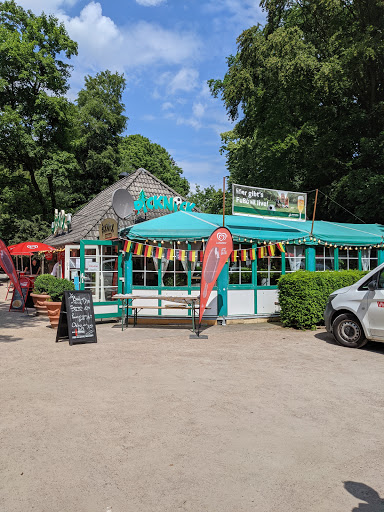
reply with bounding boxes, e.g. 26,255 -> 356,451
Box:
209,0 -> 384,222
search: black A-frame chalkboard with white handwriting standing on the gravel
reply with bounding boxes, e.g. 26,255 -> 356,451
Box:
56,290 -> 97,345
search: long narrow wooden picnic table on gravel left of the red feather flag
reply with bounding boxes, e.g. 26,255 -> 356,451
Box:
113,293 -> 200,332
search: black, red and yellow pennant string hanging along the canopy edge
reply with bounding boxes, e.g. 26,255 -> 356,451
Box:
124,240 -> 285,262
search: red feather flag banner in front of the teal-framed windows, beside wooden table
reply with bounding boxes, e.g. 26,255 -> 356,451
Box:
199,228 -> 233,325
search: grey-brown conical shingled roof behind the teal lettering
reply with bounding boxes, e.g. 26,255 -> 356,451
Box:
44,168 -> 198,247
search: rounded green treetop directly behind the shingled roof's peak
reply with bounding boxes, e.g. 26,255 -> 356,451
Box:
120,134 -> 189,196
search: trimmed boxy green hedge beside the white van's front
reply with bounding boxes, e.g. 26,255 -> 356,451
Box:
278,270 -> 367,329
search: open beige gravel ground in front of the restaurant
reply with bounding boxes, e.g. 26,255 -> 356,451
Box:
0,280 -> 384,512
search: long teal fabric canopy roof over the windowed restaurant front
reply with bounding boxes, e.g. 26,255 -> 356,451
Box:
120,211 -> 384,246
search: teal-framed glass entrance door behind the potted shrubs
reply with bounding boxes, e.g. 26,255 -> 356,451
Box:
80,240 -> 122,303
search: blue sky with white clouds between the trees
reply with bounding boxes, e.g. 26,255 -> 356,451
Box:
16,0 -> 265,190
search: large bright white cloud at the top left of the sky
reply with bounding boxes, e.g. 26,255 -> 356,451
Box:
59,1 -> 199,74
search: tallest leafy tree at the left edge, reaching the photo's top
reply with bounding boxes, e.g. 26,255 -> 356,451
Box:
0,0 -> 77,221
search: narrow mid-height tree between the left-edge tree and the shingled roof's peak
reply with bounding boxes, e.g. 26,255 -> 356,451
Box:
74,70 -> 128,203
